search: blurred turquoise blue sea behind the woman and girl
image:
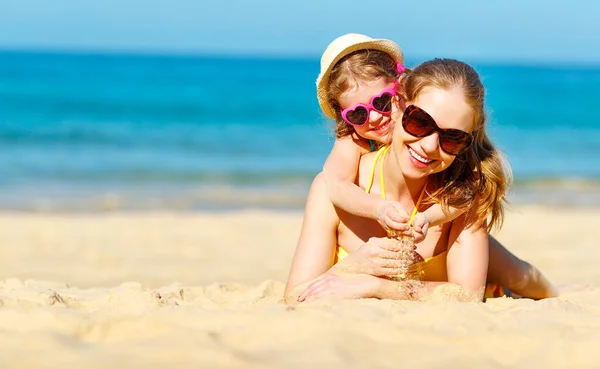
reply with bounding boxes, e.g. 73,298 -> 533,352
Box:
0,51 -> 600,212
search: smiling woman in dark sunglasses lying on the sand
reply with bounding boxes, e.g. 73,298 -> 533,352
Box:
285,59 -> 556,302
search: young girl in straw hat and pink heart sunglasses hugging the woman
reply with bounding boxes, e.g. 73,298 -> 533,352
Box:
317,34 -> 465,242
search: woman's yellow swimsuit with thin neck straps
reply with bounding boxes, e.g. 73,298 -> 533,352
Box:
334,146 -> 505,298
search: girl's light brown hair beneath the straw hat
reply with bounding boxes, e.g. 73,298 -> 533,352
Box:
326,49 -> 400,138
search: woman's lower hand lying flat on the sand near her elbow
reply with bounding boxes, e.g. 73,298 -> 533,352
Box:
298,271 -> 379,302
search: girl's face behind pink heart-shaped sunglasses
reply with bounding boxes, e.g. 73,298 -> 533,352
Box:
338,78 -> 398,144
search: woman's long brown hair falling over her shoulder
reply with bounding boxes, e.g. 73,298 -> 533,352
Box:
401,59 -> 512,232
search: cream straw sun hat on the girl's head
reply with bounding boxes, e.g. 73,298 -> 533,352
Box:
317,33 -> 404,119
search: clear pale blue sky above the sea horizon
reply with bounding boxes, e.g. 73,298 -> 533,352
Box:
0,0 -> 600,64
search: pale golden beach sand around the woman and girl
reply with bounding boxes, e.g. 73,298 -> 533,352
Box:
0,206 -> 600,369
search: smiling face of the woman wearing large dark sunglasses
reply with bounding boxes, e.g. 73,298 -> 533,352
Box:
392,87 -> 475,178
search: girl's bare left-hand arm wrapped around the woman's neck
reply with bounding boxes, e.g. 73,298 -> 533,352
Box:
323,136 -> 408,231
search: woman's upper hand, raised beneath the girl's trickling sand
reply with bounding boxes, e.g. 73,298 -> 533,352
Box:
331,237 -> 416,277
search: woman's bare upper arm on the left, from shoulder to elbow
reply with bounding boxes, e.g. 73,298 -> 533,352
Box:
285,173 -> 339,303
